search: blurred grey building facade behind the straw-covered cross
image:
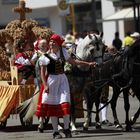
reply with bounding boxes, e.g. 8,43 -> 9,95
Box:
0,0 -> 102,34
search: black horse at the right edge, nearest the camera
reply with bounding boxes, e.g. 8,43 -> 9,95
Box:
98,43 -> 140,131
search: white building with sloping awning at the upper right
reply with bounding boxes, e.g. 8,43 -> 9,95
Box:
102,0 -> 140,44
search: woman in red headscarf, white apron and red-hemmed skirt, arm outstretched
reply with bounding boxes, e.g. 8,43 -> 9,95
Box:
39,34 -> 96,139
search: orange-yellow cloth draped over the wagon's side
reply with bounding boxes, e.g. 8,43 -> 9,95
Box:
0,85 -> 35,122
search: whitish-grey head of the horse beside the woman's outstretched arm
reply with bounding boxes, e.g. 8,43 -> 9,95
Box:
76,34 -> 104,69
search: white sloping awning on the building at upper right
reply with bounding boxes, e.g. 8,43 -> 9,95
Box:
104,8 -> 137,21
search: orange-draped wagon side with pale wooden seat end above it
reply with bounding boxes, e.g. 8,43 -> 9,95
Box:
0,59 -> 36,127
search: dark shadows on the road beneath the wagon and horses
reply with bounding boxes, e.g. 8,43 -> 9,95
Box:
0,122 -> 140,135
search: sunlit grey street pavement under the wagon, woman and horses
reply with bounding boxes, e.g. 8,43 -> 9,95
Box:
0,87 -> 140,140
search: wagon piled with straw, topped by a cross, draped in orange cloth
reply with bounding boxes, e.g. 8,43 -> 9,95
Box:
0,0 -> 83,131
